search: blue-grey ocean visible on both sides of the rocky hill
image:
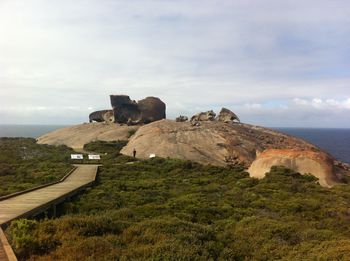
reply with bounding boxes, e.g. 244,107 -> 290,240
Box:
0,125 -> 350,163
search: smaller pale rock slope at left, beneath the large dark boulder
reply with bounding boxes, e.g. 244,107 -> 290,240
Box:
38,123 -> 138,150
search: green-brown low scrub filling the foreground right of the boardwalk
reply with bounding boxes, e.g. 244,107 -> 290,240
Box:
7,158 -> 350,260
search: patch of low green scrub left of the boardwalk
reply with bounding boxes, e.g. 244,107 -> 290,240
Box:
0,138 -> 73,196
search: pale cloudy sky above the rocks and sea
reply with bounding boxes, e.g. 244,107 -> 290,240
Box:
0,0 -> 350,128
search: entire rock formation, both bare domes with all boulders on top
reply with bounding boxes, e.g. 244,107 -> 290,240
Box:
38,106 -> 350,186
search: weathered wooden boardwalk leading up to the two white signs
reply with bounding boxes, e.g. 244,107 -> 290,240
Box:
0,165 -> 98,261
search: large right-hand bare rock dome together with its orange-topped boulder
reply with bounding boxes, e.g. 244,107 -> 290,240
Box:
121,120 -> 345,186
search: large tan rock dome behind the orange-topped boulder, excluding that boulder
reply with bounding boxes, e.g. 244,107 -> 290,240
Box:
122,120 -> 319,167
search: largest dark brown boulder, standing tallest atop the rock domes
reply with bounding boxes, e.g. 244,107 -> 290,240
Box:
110,95 -> 166,125
